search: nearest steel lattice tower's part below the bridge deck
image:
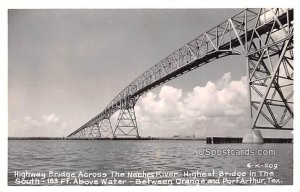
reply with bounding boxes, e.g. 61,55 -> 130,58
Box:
248,36 -> 294,129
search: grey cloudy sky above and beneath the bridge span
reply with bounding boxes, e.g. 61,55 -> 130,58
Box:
8,9 -> 290,137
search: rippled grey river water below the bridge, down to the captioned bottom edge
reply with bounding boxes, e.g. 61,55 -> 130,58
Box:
8,140 -> 293,185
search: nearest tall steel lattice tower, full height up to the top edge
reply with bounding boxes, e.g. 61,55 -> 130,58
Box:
247,9 -> 294,130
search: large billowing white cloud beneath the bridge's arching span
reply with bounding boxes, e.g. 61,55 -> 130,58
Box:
136,73 -> 250,136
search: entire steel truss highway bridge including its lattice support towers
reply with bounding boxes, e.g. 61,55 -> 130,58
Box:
68,8 -> 294,138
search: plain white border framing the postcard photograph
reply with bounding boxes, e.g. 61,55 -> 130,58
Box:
0,0 -> 300,192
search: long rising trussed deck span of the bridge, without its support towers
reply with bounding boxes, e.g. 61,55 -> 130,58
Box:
68,9 -> 293,137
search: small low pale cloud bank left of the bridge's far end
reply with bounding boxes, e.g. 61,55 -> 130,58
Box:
9,113 -> 68,137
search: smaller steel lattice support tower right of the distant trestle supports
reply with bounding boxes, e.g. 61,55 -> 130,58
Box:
113,107 -> 140,138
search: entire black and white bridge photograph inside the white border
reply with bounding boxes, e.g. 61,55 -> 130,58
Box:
2,0 -> 297,190
